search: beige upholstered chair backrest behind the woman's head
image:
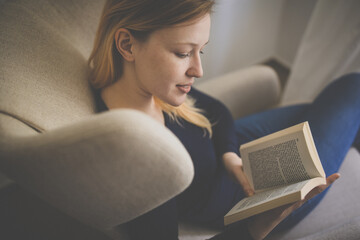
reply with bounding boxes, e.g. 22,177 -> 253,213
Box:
0,0 -> 104,132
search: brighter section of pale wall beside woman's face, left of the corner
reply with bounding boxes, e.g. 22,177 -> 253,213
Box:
203,0 -> 284,79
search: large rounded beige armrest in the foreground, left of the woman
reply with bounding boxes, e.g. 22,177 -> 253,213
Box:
0,110 -> 194,230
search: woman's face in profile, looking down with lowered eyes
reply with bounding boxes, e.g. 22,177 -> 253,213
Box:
132,14 -> 210,106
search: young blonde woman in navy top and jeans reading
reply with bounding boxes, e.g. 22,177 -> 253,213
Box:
89,0 -> 360,240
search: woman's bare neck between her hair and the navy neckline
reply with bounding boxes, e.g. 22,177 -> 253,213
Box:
101,75 -> 164,124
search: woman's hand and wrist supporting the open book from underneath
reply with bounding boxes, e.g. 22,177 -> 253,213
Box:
248,173 -> 340,240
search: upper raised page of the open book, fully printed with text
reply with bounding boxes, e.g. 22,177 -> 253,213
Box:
240,122 -> 324,192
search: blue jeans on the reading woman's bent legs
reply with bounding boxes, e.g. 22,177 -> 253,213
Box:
235,73 -> 360,229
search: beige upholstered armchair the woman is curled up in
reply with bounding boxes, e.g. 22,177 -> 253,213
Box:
0,0 -> 358,240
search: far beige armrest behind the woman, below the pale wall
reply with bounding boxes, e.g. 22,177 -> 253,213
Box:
196,65 -> 281,119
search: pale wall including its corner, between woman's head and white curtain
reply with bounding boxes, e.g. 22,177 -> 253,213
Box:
202,0 -> 316,80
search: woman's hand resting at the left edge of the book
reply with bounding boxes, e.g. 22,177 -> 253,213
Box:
223,152 -> 254,196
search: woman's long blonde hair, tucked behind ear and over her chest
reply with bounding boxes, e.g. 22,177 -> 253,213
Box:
88,0 -> 214,137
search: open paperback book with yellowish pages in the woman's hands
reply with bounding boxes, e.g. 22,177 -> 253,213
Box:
224,122 -> 326,225
